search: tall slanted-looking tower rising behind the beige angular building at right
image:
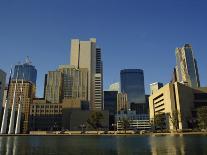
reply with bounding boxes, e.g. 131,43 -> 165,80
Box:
175,44 -> 200,88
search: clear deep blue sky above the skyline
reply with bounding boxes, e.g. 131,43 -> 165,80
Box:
0,0 -> 207,97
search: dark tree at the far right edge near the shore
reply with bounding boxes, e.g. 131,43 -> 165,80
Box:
197,107 -> 207,129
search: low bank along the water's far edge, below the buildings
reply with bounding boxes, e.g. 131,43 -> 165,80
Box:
0,131 -> 207,136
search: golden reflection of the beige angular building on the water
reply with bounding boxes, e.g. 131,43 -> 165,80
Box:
149,135 -> 185,155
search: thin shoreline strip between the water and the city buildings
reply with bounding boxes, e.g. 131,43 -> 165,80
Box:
0,132 -> 207,137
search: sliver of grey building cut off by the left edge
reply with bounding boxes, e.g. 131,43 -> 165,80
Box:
0,69 -> 6,114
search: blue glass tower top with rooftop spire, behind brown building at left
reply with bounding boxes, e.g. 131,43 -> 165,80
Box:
13,59 -> 37,85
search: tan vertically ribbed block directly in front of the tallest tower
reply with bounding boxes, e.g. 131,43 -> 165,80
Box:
58,65 -> 88,101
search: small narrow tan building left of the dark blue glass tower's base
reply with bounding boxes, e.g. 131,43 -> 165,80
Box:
117,93 -> 130,113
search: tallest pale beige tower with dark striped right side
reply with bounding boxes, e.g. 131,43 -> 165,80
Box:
70,38 -> 103,110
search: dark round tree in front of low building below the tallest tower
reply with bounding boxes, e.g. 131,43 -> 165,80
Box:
87,111 -> 104,134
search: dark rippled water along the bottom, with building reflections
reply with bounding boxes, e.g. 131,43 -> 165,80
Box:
0,135 -> 207,155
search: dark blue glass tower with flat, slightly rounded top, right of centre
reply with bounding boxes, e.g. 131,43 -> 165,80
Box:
121,69 -> 146,105
